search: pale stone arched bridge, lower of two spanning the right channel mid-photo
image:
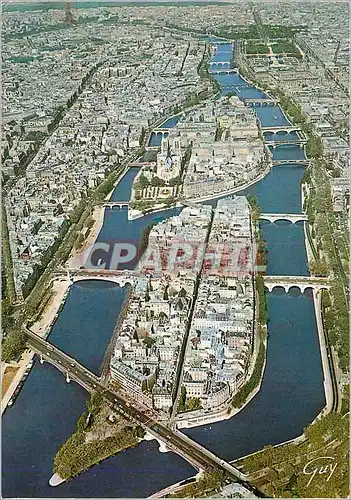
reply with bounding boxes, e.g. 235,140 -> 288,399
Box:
263,276 -> 330,293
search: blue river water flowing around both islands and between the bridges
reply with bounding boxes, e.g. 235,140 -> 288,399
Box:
2,44 -> 325,498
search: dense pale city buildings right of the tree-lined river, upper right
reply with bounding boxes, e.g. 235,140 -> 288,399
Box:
239,2 -> 350,218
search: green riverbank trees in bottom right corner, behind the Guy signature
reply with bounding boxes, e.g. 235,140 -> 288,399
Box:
235,404 -> 349,498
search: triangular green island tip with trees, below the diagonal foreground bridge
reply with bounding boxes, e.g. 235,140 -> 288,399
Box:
54,393 -> 144,479
